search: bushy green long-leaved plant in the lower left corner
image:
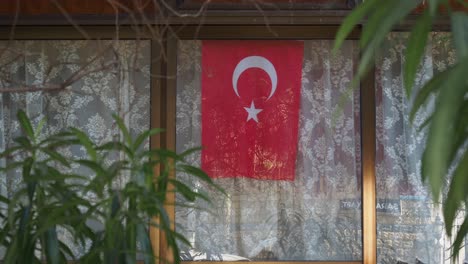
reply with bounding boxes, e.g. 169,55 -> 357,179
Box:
0,111 -> 218,264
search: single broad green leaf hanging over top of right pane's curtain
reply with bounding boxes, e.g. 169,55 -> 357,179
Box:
403,11 -> 432,97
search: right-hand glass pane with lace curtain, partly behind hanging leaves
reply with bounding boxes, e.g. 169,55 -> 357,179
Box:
376,33 -> 466,263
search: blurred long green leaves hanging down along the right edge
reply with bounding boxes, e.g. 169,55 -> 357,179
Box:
335,0 -> 468,259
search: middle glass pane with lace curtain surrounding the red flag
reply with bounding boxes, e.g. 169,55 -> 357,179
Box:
176,40 -> 362,261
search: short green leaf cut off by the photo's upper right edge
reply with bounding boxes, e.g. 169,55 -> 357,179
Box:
451,12 -> 468,58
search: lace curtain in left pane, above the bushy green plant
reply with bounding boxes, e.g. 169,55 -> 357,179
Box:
0,40 -> 150,252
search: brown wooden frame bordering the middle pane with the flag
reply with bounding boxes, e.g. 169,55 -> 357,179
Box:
160,25 -> 377,264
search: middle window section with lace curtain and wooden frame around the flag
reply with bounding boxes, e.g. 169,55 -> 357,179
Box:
156,26 -> 363,263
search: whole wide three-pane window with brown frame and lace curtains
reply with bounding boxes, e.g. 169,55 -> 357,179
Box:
0,23 -> 467,264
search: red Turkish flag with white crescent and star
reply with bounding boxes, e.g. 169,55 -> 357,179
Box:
202,40 -> 304,181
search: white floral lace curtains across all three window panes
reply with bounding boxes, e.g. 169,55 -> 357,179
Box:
0,33 -> 464,263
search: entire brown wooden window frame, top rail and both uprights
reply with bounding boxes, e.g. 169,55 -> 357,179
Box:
0,24 -> 377,264
